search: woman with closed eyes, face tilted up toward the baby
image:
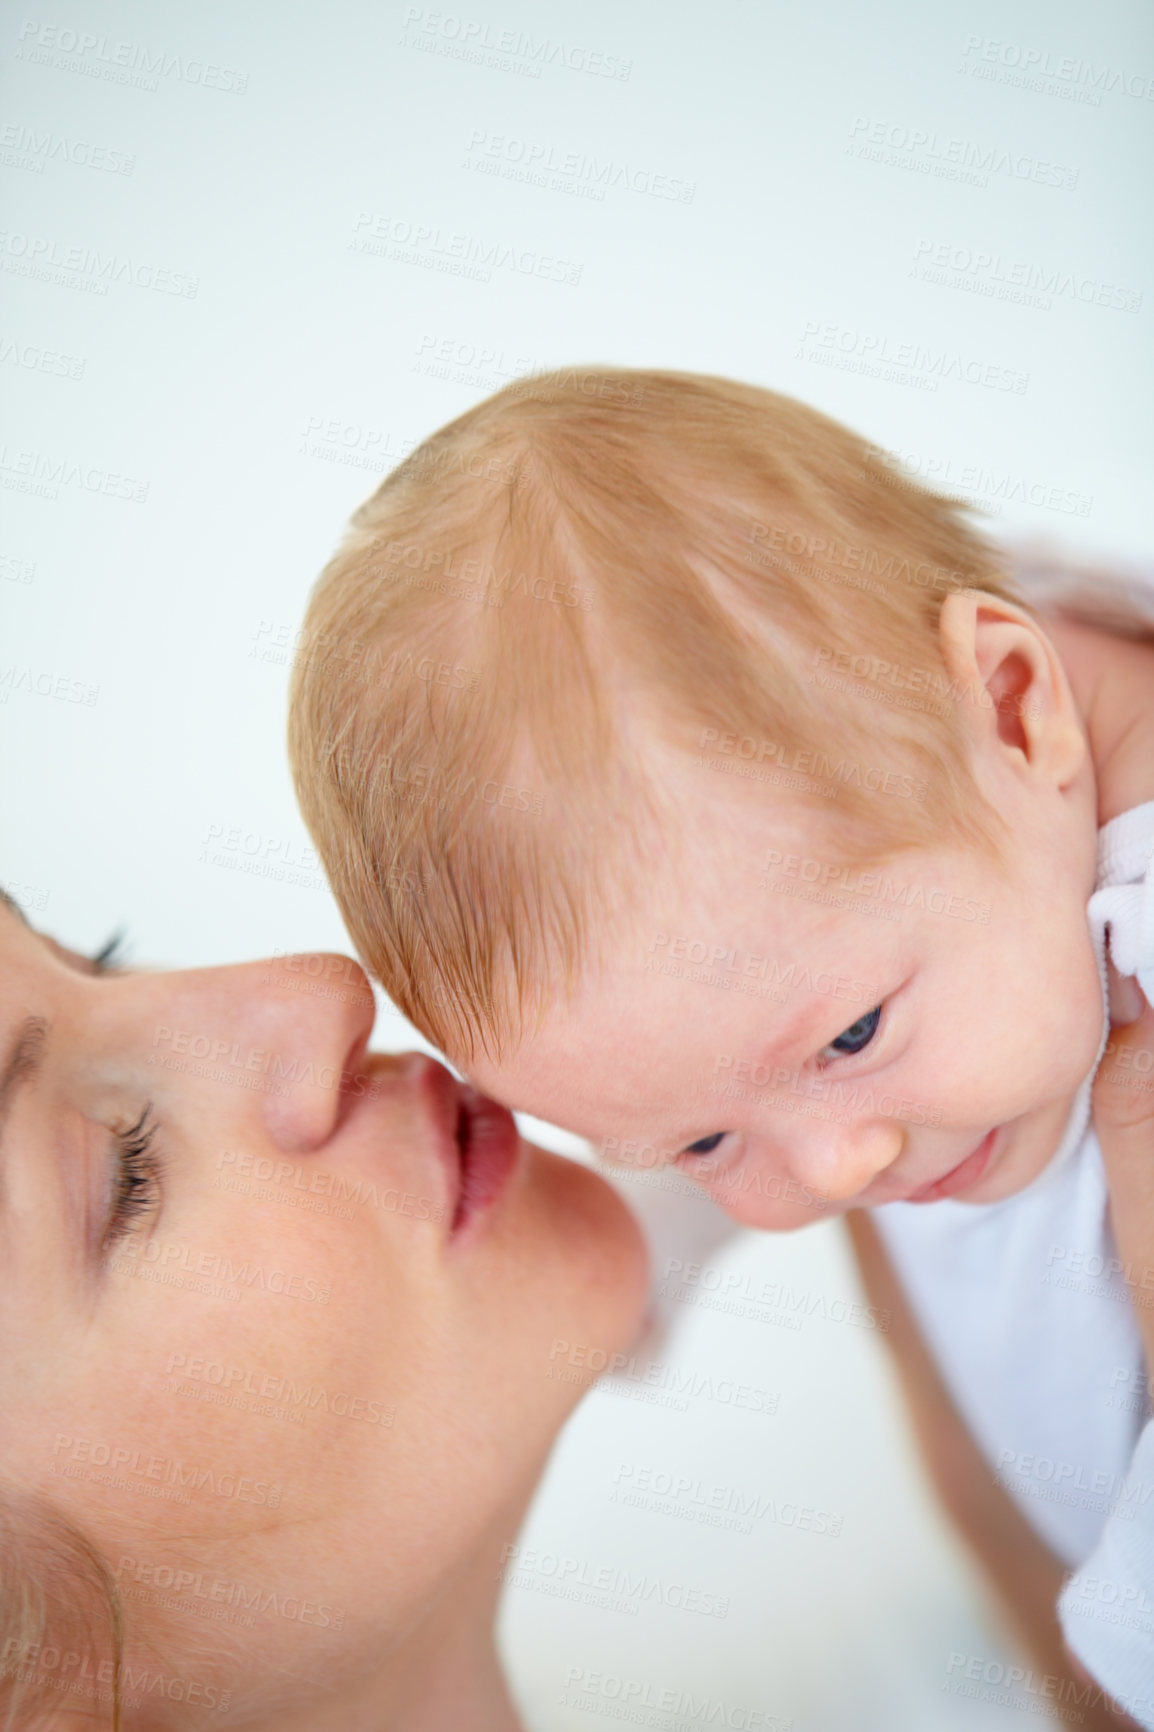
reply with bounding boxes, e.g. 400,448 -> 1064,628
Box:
0,906 -> 645,1732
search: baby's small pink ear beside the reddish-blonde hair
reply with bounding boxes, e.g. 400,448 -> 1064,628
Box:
939,589 -> 1088,786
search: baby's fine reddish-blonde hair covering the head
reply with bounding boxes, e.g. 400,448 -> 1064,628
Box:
289,367 -> 1019,1058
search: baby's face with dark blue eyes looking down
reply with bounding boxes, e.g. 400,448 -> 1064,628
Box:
470,751 -> 1104,1228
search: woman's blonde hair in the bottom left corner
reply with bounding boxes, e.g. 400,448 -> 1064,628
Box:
0,1486 -> 125,1732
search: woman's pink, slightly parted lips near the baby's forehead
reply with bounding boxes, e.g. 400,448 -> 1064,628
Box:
407,1055 -> 520,1238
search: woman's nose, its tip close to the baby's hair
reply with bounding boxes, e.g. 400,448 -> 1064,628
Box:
170,954 -> 376,1154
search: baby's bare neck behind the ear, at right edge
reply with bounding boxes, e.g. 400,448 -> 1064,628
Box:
1041,613 -> 1154,824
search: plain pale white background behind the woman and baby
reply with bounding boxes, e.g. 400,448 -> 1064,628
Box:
0,0 -> 1154,1732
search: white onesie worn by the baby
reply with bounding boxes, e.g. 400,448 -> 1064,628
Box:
873,800 -> 1154,1732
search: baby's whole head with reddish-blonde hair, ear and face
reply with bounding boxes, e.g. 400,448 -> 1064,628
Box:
289,369 -> 1102,1226
